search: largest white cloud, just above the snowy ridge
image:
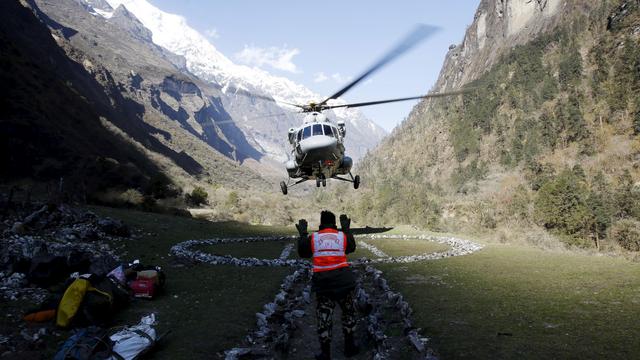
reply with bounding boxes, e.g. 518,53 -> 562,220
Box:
235,45 -> 301,74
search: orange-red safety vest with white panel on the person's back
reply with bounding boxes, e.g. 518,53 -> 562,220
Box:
311,229 -> 349,272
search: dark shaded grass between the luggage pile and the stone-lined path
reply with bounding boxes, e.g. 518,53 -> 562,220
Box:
91,207 -> 295,359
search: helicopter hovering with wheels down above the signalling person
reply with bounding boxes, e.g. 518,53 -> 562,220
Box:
279,25 -> 464,195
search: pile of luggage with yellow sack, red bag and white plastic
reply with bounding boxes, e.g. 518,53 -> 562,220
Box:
24,260 -> 166,360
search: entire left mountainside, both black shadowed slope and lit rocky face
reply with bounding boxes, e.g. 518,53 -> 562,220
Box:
1,0 -> 276,202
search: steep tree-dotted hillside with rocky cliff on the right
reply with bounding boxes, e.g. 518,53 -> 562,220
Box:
352,0 -> 640,247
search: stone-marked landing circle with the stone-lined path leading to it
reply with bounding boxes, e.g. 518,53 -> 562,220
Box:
171,235 -> 482,360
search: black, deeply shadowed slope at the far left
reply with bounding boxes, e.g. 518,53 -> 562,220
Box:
0,1 -> 170,194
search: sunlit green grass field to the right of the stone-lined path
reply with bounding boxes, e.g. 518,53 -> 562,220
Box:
380,245 -> 640,359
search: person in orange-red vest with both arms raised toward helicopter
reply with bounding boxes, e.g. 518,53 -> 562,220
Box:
296,211 -> 359,360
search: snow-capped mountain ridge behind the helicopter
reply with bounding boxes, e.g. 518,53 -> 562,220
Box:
95,0 -> 386,160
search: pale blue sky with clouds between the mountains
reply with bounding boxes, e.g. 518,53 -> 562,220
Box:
149,0 -> 479,130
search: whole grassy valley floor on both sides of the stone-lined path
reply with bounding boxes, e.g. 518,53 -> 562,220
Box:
6,207 -> 640,359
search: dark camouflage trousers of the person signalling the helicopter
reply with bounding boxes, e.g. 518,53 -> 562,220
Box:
316,290 -> 357,346
